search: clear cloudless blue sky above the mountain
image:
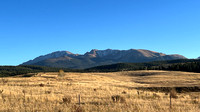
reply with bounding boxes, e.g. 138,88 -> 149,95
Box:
0,0 -> 200,65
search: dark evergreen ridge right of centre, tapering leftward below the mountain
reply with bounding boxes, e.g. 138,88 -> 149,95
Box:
85,59 -> 200,73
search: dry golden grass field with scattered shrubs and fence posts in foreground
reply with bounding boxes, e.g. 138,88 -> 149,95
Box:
0,71 -> 200,112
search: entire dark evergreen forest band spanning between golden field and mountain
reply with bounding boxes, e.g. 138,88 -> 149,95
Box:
0,59 -> 200,77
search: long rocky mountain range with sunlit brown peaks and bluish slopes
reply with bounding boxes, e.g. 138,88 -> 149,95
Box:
22,49 -> 186,69
